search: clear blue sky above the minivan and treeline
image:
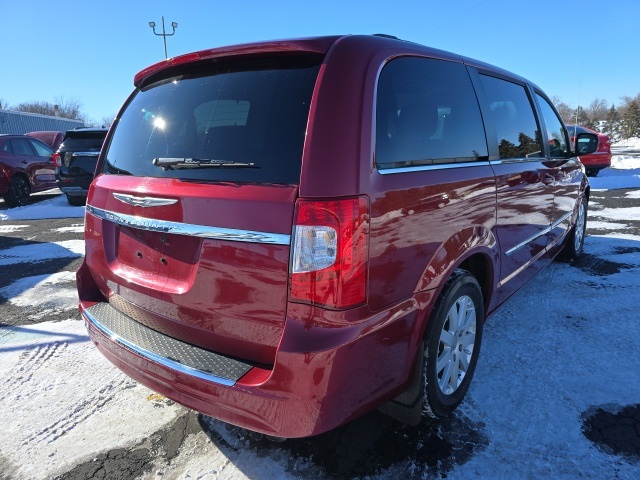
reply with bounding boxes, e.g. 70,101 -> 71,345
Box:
0,0 -> 640,121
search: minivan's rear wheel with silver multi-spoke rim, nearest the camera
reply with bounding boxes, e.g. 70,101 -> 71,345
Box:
422,269 -> 484,418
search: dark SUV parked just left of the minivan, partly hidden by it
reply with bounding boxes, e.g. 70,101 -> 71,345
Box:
53,128 -> 108,206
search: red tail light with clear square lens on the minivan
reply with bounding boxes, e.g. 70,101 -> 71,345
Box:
289,197 -> 369,309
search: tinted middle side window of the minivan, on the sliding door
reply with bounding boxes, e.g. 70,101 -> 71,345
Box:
480,75 -> 542,158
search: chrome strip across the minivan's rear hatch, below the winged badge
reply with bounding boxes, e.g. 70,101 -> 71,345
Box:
87,205 -> 291,245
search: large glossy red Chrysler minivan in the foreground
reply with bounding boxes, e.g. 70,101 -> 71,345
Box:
77,36 -> 589,438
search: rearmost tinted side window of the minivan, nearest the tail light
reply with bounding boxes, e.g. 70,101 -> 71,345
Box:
376,57 -> 488,168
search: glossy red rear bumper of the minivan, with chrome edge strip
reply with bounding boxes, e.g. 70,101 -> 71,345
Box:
80,292 -> 432,437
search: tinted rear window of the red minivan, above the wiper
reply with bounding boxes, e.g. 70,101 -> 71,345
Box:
102,56 -> 322,184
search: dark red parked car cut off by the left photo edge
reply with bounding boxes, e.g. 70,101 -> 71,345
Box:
0,135 -> 56,207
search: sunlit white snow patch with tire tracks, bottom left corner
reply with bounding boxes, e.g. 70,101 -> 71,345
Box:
0,320 -> 181,479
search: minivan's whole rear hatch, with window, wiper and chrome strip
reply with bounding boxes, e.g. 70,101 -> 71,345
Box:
85,54 -> 322,365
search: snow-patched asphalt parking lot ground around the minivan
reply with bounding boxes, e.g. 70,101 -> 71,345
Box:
0,169 -> 640,480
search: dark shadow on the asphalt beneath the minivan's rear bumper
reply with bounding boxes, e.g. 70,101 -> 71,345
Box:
198,412 -> 489,479
